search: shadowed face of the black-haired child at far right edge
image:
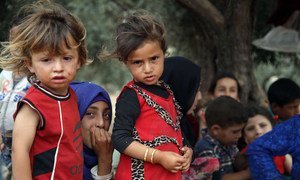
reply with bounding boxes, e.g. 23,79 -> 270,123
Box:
272,99 -> 300,120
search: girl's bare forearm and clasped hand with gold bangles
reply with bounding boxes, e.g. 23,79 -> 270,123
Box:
123,141 -> 186,173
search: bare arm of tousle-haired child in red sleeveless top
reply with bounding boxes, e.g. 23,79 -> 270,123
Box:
12,104 -> 39,180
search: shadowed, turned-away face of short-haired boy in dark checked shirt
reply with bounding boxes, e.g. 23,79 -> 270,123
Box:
215,124 -> 244,146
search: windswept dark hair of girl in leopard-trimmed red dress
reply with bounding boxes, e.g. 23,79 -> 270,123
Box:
112,10 -> 167,62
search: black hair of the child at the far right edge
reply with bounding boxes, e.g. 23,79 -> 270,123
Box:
268,78 -> 300,106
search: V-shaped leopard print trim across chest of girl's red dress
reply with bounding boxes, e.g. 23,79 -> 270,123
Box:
131,81 -> 182,131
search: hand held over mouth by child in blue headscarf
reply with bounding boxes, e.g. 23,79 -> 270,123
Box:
91,127 -> 113,163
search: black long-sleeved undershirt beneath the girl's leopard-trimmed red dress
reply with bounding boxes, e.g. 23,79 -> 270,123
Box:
112,82 -> 169,153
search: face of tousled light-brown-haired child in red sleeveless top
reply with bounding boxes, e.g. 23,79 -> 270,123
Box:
27,44 -> 80,95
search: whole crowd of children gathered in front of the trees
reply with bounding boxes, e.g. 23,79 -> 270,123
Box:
0,0 -> 300,180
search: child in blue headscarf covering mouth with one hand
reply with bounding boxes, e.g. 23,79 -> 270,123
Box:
71,82 -> 113,180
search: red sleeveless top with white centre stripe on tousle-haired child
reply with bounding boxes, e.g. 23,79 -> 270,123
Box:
22,87 -> 83,179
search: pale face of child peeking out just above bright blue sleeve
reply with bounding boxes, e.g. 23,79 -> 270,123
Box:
244,114 -> 272,144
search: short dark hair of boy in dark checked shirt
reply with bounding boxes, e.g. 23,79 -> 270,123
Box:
205,96 -> 247,128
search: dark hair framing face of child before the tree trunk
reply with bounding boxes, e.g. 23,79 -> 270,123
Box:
208,72 -> 242,98
